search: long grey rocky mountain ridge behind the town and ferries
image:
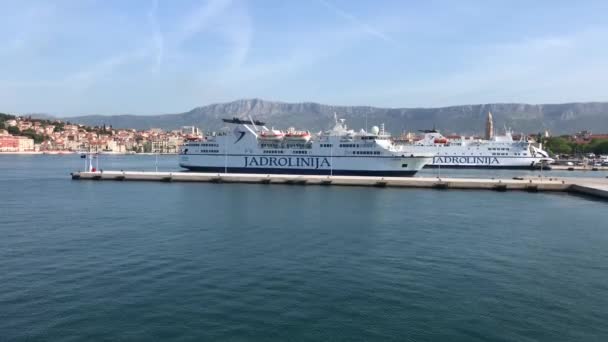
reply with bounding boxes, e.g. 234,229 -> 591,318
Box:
59,99 -> 608,134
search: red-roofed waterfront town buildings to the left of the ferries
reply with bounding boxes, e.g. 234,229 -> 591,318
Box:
0,114 -> 202,154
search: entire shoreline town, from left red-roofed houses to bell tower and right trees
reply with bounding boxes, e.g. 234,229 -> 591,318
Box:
0,113 -> 608,160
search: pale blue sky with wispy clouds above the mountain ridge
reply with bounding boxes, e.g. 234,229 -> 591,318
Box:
0,0 -> 608,116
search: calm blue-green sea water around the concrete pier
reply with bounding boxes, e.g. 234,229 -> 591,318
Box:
0,156 -> 608,341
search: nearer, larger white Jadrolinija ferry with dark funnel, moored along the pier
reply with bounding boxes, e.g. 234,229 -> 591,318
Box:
179,118 -> 433,176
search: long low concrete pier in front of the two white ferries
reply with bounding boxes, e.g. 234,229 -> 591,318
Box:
72,171 -> 608,199
